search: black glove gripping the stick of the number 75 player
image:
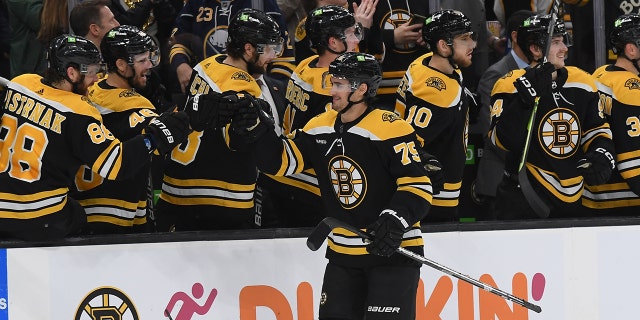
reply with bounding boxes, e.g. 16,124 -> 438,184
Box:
367,209 -> 409,257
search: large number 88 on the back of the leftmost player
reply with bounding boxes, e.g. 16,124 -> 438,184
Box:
0,115 -> 49,182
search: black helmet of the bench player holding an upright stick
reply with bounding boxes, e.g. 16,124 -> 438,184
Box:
518,14 -> 571,61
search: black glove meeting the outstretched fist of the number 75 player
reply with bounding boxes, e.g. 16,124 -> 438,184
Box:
184,91 -> 244,131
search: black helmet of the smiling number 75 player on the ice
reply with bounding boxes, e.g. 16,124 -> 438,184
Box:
329,52 -> 382,98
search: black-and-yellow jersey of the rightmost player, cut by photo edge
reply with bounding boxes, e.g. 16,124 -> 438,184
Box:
582,65 -> 640,213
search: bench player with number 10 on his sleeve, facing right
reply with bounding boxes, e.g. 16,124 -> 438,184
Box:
395,10 -> 476,221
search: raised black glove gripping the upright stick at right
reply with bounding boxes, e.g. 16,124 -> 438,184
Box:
513,62 -> 556,108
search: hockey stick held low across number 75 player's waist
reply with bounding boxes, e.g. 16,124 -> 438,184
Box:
307,217 -> 542,313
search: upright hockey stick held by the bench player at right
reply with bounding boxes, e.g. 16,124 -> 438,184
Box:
518,0 -> 560,218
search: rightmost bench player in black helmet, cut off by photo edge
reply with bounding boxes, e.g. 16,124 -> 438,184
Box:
582,14 -> 640,216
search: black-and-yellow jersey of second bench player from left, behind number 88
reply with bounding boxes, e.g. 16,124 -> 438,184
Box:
72,80 -> 158,232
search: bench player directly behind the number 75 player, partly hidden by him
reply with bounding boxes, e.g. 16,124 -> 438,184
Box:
260,5 -> 361,227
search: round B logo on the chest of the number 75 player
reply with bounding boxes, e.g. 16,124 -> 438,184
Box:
329,155 -> 367,209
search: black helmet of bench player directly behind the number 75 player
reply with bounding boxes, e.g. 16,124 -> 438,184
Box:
304,5 -> 361,50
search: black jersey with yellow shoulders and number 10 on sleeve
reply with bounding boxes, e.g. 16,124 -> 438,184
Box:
395,53 -> 469,208
